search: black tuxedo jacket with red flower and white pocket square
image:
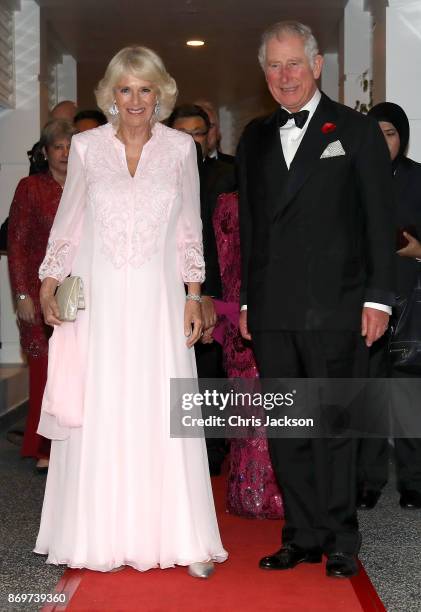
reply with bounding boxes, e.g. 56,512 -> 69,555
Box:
237,94 -> 395,331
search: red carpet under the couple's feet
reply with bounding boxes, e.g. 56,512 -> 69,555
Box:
42,476 -> 385,612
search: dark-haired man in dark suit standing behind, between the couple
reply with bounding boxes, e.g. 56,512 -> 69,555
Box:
167,104 -> 236,476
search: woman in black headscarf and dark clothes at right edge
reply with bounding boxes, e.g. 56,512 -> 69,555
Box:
357,102 -> 421,510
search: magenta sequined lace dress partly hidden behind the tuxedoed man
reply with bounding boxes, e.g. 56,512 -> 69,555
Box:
213,193 -> 283,519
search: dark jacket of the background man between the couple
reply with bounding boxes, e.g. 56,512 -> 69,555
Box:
199,157 -> 236,298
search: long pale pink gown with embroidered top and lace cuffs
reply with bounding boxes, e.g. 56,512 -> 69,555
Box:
35,123 -> 227,571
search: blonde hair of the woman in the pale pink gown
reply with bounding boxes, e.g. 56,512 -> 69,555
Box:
95,45 -> 178,123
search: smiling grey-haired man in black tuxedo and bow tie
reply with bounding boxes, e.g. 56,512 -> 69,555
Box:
238,22 -> 394,577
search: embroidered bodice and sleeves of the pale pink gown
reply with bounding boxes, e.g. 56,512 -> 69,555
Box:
40,123 -> 204,282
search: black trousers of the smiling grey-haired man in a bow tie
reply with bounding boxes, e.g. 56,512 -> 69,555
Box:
252,331 -> 368,554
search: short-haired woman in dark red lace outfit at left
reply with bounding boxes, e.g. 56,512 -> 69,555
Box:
8,119 -> 74,472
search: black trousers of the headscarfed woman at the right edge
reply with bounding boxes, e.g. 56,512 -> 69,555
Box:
357,336 -> 421,493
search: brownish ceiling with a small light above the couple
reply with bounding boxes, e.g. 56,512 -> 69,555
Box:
38,0 -> 346,108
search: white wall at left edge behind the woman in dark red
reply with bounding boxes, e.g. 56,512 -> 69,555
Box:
0,0 -> 40,363
